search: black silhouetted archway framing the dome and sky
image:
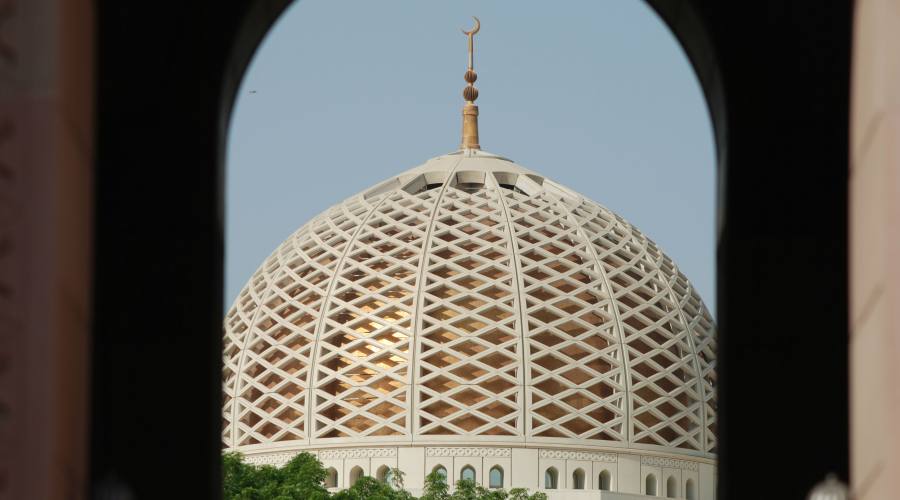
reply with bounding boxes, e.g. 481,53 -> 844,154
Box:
88,0 -> 852,498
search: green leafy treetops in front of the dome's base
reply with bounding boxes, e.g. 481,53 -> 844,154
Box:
222,453 -> 547,500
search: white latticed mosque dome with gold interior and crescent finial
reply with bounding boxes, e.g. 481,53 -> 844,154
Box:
223,19 -> 716,500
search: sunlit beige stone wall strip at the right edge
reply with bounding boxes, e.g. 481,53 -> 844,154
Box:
852,0 -> 900,500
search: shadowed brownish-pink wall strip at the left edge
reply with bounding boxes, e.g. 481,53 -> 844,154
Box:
0,0 -> 93,500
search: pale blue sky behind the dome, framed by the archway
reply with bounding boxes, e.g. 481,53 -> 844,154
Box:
223,0 -> 715,312
